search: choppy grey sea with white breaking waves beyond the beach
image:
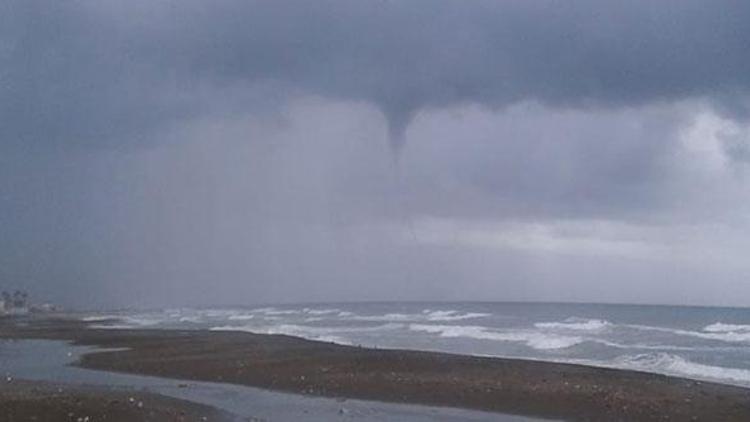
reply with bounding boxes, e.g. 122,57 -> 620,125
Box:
86,302 -> 750,387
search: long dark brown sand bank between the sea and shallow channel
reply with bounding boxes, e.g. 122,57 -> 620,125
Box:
0,319 -> 750,421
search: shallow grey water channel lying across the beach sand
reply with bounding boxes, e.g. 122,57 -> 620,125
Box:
0,340 -> 552,422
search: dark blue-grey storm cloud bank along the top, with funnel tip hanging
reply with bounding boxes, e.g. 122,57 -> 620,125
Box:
0,0 -> 750,152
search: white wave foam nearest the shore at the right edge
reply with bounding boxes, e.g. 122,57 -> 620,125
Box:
612,353 -> 750,385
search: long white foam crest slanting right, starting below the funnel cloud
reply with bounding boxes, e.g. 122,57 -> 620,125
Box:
409,324 -> 585,350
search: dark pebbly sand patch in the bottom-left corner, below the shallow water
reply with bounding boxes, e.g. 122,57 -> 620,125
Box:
0,380 -> 238,422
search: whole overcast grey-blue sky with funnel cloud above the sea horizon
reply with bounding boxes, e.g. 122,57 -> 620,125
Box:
0,0 -> 750,306
